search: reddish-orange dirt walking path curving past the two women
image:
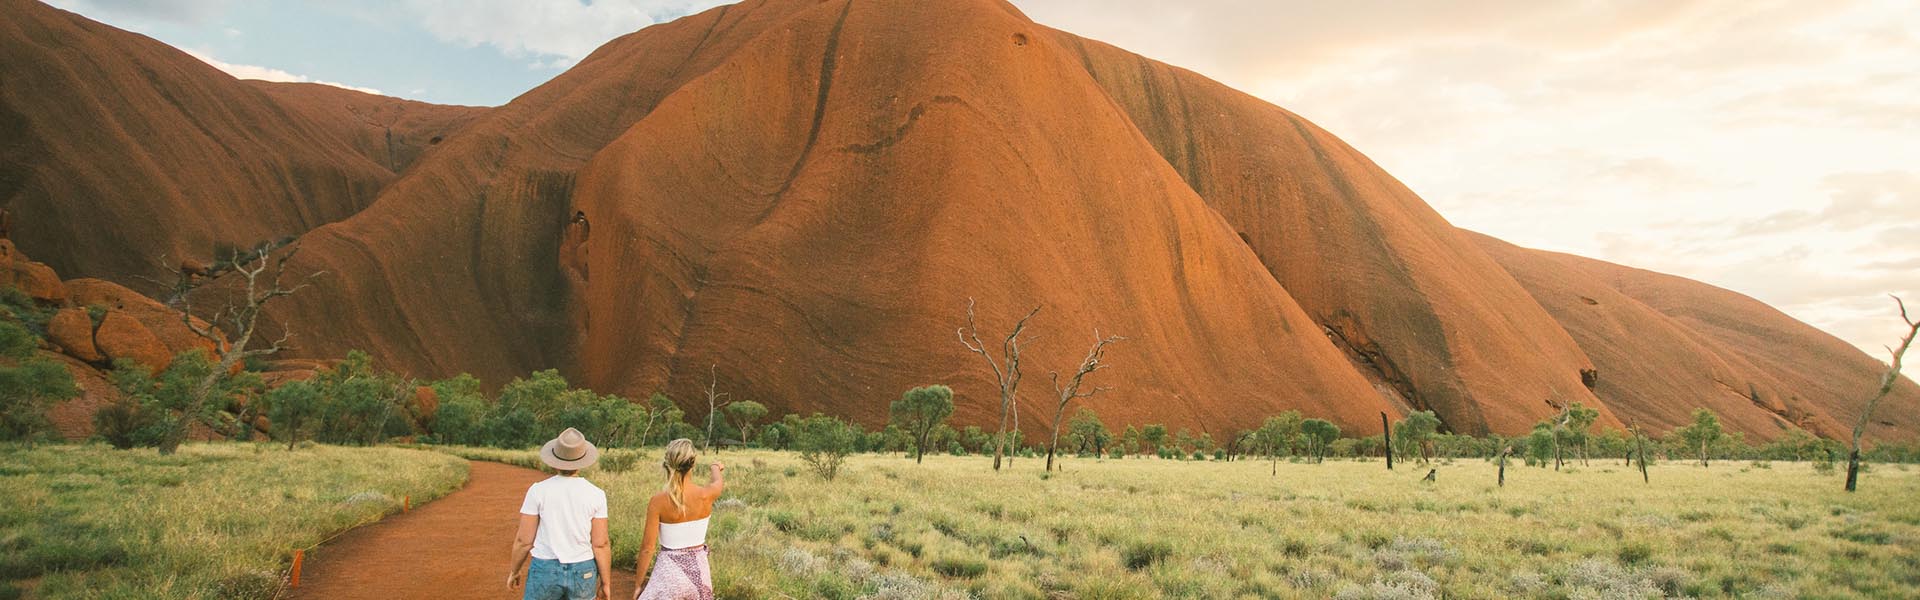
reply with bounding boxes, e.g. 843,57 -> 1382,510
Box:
288,462 -> 634,600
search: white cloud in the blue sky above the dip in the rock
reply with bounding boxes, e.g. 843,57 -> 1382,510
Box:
405,0 -> 724,69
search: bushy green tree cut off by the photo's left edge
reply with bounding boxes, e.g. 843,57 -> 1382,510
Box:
0,321 -> 81,450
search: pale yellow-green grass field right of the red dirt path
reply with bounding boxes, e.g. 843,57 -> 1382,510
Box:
455,450 -> 1920,598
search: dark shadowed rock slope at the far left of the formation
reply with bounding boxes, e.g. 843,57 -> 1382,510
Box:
0,0 -> 472,283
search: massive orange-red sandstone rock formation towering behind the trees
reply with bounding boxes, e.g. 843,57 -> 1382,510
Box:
0,0 -> 1916,438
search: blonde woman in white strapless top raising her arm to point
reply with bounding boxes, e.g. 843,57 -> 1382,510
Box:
634,438 -> 726,600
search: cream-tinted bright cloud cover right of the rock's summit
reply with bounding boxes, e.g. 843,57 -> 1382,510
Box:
1014,0 -> 1920,355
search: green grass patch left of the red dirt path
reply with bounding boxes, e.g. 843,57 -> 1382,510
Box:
0,444 -> 467,600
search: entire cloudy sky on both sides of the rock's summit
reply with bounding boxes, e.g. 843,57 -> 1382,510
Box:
50,0 -> 1920,360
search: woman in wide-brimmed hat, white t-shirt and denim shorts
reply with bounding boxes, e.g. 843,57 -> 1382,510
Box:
507,427 -> 612,600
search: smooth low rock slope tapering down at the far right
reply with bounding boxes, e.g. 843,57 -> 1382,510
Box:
1469,233 -> 1920,438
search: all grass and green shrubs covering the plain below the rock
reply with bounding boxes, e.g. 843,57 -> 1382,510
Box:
0,286 -> 1920,600
